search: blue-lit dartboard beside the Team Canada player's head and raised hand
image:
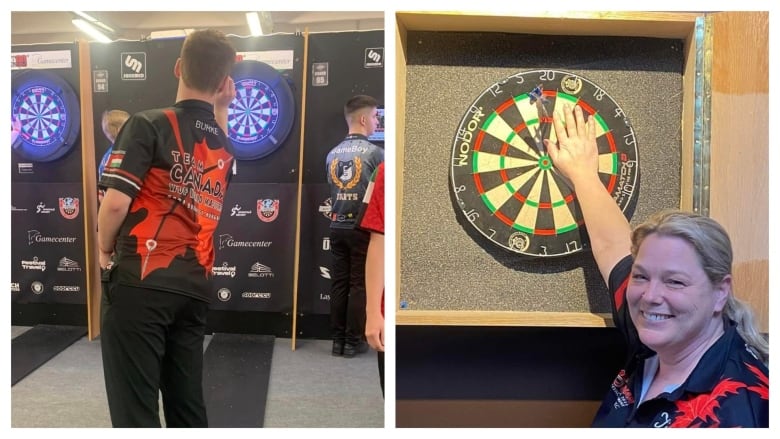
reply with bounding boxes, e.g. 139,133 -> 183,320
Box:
228,60 -> 295,160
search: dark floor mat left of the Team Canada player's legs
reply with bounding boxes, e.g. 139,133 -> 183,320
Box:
11,325 -> 87,386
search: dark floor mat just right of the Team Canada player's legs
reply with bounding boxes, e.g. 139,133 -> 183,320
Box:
203,333 -> 275,428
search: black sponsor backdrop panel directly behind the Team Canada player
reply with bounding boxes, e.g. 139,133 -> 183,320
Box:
90,35 -> 303,336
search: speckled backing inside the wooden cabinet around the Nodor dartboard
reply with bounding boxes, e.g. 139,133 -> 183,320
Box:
399,32 -> 683,313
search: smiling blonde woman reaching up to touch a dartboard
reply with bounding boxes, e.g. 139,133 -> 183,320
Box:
545,104 -> 769,427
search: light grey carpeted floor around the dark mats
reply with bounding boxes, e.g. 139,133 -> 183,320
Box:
11,326 -> 385,428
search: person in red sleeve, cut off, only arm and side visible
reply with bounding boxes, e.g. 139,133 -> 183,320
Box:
360,162 -> 385,395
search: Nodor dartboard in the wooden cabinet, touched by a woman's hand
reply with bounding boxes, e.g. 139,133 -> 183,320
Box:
450,70 -> 639,257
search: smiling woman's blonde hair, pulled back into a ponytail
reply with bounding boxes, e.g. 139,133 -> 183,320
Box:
631,210 -> 769,364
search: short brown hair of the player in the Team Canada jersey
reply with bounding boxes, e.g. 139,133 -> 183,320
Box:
180,29 -> 236,93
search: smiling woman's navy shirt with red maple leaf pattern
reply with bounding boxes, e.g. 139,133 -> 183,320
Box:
593,256 -> 769,428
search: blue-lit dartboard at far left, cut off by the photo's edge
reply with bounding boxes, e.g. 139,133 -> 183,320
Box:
11,70 -> 81,162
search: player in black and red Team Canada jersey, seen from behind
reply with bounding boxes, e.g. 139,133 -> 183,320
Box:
98,30 -> 236,427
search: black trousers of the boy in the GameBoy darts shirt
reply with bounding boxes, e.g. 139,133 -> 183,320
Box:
330,229 -> 371,345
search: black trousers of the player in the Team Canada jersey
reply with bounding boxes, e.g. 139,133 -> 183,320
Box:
100,268 -> 208,427
